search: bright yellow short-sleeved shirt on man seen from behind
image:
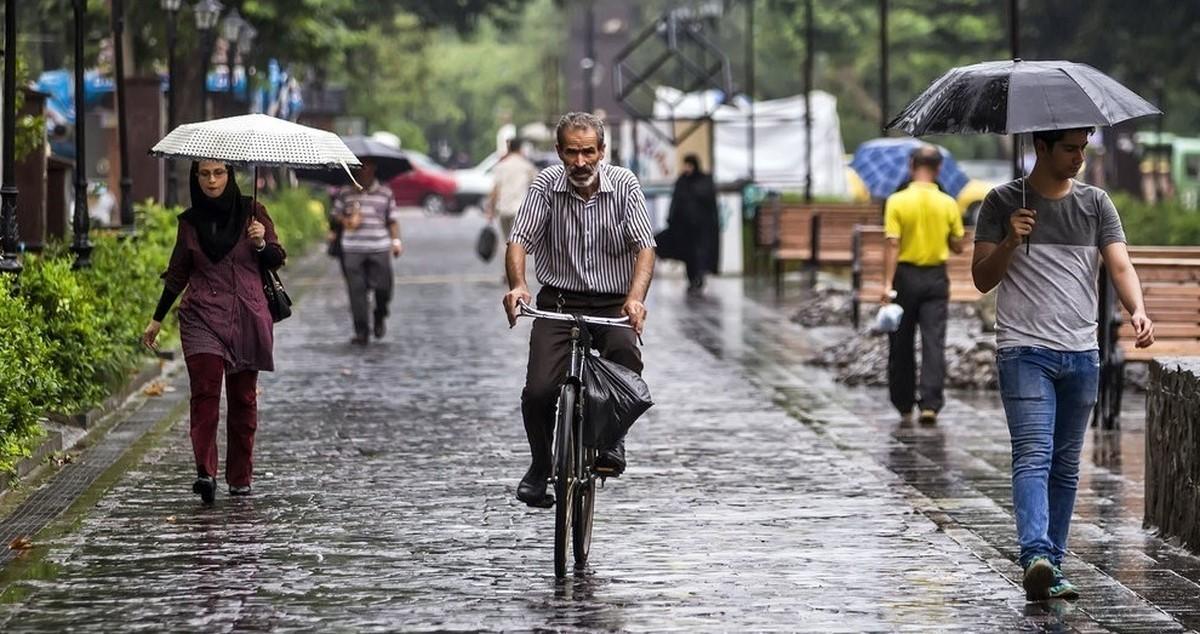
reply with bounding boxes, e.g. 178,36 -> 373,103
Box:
883,183 -> 962,267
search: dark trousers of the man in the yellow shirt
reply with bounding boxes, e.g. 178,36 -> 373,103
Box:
888,263 -> 950,413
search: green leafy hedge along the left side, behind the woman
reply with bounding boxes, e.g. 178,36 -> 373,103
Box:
0,189 -> 326,472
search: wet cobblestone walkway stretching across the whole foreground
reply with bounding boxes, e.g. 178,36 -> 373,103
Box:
0,211 -> 1200,632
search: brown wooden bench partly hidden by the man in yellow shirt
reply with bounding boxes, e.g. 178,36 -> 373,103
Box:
851,225 -> 983,328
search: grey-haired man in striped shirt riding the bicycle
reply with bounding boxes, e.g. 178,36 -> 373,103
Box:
504,113 -> 654,507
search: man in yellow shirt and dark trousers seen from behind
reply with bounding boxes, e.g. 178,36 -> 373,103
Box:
882,145 -> 962,424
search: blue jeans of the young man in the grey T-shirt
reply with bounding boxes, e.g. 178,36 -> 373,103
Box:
996,346 -> 1100,567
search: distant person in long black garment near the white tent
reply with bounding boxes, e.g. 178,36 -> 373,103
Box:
667,154 -> 720,295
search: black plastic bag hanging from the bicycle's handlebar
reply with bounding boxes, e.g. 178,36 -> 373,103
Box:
583,354 -> 654,450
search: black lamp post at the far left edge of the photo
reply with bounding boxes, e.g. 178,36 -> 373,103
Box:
0,0 -> 22,274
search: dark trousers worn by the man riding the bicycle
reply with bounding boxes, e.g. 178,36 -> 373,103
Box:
521,287 -> 642,476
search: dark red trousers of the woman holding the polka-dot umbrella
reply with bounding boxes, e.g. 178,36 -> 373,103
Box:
186,354 -> 258,486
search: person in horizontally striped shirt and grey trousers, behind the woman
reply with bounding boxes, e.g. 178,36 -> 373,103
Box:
331,157 -> 404,346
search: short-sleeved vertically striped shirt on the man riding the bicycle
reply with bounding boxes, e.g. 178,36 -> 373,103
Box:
509,163 -> 654,295
